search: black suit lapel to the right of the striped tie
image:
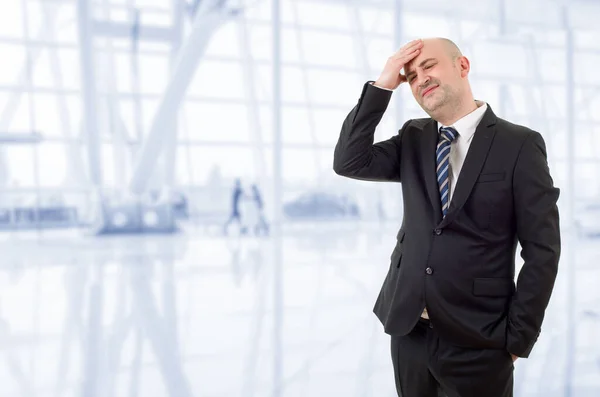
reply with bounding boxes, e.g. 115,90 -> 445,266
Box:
434,105 -> 496,227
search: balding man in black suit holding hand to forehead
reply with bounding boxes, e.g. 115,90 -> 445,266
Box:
333,38 -> 560,397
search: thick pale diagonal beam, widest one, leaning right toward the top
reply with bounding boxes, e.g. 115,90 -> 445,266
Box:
130,2 -> 227,194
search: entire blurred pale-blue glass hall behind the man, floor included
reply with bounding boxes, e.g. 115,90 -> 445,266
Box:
0,0 -> 600,397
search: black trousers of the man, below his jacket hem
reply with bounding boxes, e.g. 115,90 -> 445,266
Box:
391,319 -> 514,397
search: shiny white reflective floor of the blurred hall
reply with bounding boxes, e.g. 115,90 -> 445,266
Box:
0,223 -> 600,397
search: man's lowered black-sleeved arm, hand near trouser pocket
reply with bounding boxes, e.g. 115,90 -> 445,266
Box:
506,132 -> 561,357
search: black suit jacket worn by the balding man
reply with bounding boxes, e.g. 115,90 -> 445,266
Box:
333,82 -> 560,357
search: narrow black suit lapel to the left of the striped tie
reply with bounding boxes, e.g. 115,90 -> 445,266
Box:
420,120 -> 442,225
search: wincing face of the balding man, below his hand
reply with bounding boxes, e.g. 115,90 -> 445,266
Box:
404,41 -> 463,115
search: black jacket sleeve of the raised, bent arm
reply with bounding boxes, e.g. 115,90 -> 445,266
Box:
333,82 -> 409,182
